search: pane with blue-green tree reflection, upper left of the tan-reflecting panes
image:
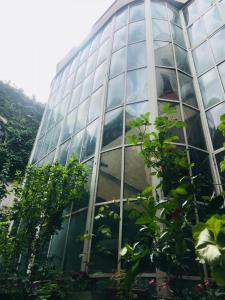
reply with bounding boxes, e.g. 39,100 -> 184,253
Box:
81,120 -> 99,161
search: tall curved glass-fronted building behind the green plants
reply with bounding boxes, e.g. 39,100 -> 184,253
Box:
31,0 -> 225,275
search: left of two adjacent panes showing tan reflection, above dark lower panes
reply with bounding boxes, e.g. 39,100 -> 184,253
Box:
97,149 -> 122,202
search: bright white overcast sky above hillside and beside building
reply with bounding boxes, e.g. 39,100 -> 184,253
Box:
0,0 -> 114,103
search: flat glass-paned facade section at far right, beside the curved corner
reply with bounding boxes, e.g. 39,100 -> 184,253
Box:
183,0 -> 225,183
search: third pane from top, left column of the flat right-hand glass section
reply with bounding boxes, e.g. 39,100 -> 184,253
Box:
193,42 -> 213,75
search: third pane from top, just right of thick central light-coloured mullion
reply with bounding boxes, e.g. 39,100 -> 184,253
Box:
154,41 -> 174,67
